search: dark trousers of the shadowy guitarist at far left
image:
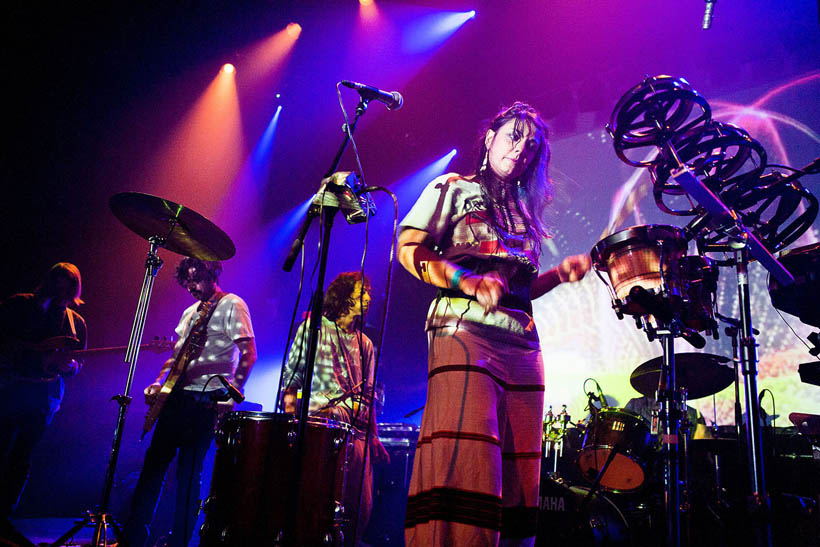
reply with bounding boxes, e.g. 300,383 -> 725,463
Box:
0,378 -> 64,518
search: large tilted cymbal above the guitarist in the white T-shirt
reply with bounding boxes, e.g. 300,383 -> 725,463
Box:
108,192 -> 236,260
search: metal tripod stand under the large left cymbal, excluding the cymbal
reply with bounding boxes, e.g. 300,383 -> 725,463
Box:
50,235 -> 167,547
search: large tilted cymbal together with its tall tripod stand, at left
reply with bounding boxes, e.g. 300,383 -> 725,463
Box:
52,192 -> 236,547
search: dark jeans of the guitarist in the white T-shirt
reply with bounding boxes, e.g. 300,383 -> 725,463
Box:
124,390 -> 216,547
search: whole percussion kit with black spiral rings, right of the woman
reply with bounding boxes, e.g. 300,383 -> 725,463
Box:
539,76 -> 820,547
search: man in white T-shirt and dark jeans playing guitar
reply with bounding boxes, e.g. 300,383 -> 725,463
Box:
124,258 -> 256,547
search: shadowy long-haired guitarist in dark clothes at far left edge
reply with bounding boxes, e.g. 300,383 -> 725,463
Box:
0,262 -> 87,519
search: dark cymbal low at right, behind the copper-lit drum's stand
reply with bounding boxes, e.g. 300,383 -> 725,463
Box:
629,352 -> 735,400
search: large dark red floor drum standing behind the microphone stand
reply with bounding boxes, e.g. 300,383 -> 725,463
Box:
200,411 -> 351,546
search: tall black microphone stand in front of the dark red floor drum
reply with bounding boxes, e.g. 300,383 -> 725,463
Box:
279,96 -> 369,545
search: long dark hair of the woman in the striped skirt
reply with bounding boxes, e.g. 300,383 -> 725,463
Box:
476,102 -> 554,242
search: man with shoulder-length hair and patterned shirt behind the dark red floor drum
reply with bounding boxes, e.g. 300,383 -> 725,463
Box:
282,272 -> 389,545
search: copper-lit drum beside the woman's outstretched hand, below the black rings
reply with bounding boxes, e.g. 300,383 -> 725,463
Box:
590,224 -> 688,315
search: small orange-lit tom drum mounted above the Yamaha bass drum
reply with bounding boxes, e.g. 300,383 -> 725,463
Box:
578,408 -> 651,492
